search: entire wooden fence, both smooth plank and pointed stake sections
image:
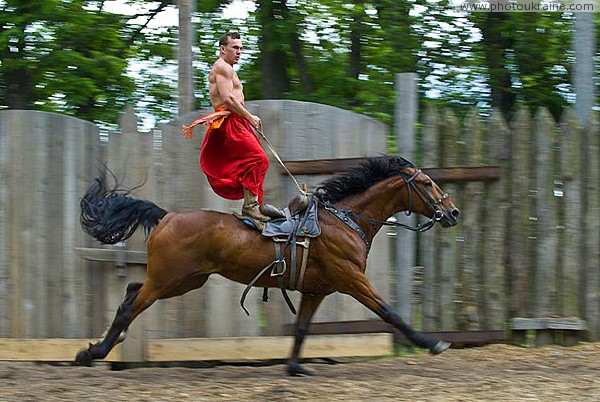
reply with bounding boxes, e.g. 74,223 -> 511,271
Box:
0,101 -> 600,360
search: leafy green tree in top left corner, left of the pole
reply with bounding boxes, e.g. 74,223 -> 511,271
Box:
0,0 -> 134,121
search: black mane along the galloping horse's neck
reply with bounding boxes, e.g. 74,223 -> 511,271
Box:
316,155 -> 415,202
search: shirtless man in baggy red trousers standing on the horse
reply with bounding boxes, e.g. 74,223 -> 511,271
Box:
184,32 -> 285,222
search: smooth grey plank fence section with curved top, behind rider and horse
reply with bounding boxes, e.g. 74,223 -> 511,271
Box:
0,101 -> 389,360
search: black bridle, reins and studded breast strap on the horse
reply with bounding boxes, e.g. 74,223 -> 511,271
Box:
321,169 -> 449,251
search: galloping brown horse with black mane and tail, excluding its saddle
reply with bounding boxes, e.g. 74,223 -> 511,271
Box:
76,156 -> 459,375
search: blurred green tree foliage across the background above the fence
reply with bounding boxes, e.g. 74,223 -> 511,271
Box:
0,0 -> 600,129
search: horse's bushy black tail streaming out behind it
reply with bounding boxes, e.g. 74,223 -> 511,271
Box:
80,170 -> 167,244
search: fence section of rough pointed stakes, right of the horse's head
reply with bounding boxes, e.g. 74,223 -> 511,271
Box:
414,108 -> 600,340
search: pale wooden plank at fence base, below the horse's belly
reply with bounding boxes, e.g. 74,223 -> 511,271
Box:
147,334 -> 392,361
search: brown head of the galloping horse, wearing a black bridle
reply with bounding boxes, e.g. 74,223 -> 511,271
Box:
402,167 -> 460,228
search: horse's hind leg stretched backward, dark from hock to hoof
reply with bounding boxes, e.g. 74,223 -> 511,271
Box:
75,283 -> 156,366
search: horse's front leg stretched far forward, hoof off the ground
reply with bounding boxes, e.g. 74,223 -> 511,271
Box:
340,272 -> 451,355
